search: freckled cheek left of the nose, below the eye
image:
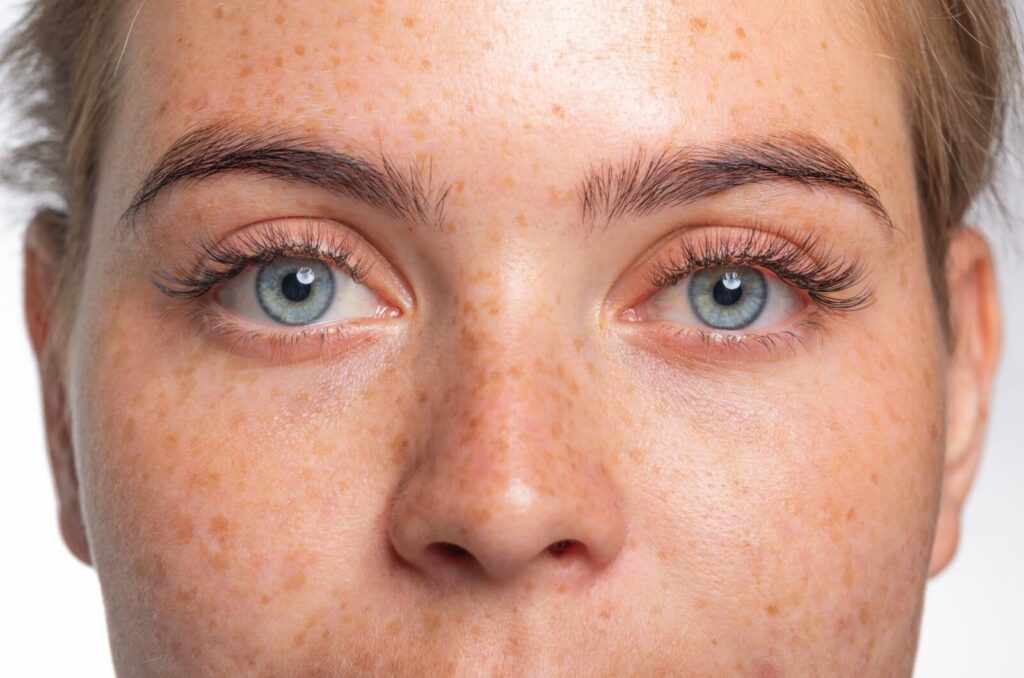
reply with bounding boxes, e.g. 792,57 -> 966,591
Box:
73,297 -> 408,656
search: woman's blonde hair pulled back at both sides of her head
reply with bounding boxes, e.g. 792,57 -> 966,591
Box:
3,0 -> 1018,307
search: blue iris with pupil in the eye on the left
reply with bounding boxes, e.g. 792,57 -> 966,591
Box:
256,257 -> 335,326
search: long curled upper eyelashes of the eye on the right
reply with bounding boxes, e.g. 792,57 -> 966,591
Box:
649,229 -> 873,312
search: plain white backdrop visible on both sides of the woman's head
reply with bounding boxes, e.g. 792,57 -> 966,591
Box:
0,0 -> 1024,678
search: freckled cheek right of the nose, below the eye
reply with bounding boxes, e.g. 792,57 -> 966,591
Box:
636,307 -> 942,670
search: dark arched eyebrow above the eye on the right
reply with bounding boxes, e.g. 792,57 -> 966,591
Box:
580,134 -> 895,230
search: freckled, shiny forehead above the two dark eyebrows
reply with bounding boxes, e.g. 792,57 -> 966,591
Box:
105,0 -> 909,220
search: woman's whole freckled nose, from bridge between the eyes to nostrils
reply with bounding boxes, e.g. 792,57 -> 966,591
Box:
390,292 -> 625,579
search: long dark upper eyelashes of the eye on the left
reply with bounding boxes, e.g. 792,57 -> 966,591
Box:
152,222 -> 370,299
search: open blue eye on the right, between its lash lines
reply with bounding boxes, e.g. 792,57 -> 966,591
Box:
637,266 -> 802,332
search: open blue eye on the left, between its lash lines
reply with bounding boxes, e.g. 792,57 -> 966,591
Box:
216,257 -> 388,327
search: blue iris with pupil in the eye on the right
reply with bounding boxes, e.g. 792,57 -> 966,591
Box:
688,266 -> 768,330
